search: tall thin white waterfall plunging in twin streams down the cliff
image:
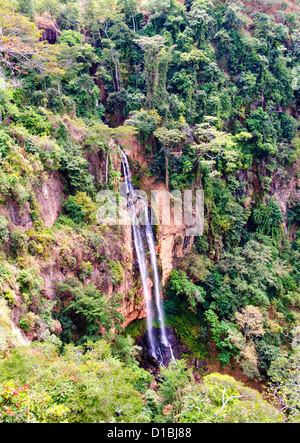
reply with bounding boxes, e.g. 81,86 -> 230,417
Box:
120,148 -> 175,365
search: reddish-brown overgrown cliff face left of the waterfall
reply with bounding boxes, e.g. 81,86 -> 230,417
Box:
0,155 -> 146,340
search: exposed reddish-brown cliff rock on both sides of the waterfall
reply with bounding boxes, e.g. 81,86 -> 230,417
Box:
0,139 -> 300,346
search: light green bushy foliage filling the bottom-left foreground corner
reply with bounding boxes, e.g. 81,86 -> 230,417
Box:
0,341 -> 148,423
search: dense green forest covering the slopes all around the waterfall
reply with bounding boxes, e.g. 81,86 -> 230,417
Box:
0,0 -> 300,423
